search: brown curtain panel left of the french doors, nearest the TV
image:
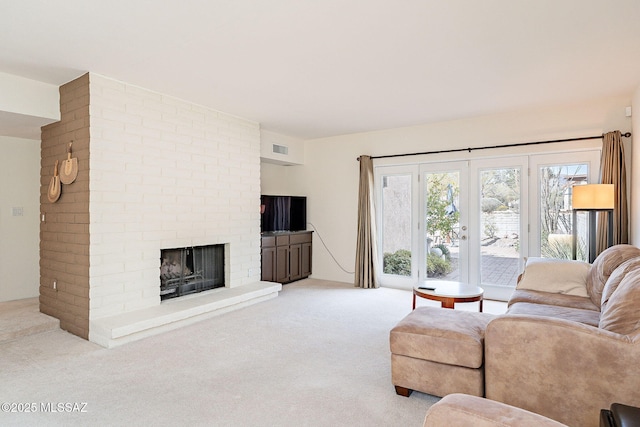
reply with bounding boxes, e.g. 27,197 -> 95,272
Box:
355,156 -> 379,288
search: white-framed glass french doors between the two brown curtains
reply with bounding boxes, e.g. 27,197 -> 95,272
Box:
375,151 -> 599,300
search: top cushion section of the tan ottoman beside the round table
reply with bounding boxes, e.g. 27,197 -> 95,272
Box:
389,307 -> 495,369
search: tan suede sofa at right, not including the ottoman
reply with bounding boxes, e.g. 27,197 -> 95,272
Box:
484,245 -> 640,426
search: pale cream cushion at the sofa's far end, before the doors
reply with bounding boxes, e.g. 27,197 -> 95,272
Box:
516,257 -> 591,297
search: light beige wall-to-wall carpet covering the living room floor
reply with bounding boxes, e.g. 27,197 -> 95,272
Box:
0,279 -> 500,426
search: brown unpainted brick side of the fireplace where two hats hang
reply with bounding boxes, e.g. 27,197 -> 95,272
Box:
40,74 -> 89,339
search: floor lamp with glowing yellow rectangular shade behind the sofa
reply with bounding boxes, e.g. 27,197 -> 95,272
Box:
571,184 -> 614,263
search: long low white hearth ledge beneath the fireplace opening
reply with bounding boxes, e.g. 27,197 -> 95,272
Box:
89,282 -> 282,348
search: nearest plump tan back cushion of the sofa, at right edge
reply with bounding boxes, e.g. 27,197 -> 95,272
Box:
600,270 -> 640,335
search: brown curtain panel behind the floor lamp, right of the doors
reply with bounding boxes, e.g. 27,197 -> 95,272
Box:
596,130 -> 629,254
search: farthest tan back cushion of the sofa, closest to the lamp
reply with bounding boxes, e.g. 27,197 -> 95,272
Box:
587,245 -> 640,307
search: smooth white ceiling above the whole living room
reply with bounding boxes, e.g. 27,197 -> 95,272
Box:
0,0 -> 640,138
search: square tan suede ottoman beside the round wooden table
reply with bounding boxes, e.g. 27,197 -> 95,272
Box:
389,307 -> 495,396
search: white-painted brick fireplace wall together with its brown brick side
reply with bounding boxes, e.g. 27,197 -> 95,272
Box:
41,73 -> 260,338
